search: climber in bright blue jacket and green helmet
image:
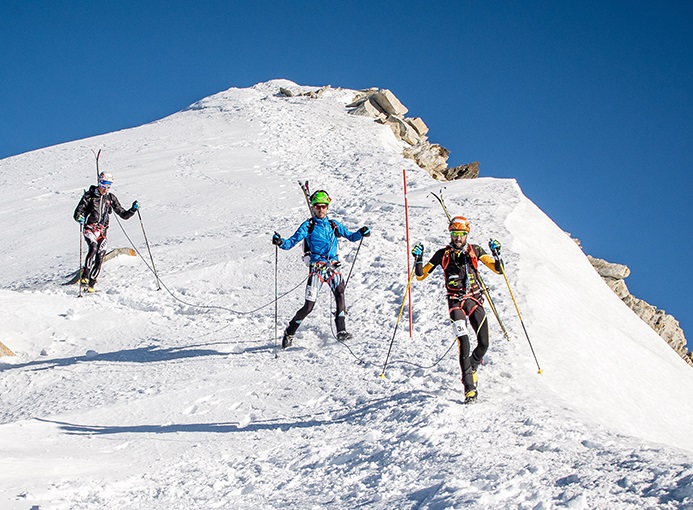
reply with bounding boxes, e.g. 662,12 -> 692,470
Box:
272,190 -> 371,349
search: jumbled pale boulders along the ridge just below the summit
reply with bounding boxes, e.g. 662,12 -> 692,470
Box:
347,88 -> 479,181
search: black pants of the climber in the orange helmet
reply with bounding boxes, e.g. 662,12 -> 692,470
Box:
448,296 -> 489,391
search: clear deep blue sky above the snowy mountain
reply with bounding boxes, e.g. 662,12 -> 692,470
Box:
0,0 -> 693,346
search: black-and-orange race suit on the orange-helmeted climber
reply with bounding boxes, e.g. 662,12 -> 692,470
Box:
416,244 -> 501,390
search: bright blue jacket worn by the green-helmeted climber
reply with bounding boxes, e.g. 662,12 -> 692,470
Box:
279,218 -> 363,263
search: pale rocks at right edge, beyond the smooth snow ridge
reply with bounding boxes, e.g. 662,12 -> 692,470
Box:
578,255 -> 693,366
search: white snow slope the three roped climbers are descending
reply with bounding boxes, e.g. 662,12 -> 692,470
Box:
0,80 -> 693,509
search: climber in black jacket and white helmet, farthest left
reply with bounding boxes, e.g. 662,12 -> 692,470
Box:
72,170 -> 140,295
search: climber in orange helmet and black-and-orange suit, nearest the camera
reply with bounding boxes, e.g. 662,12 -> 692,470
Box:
412,216 -> 502,404
